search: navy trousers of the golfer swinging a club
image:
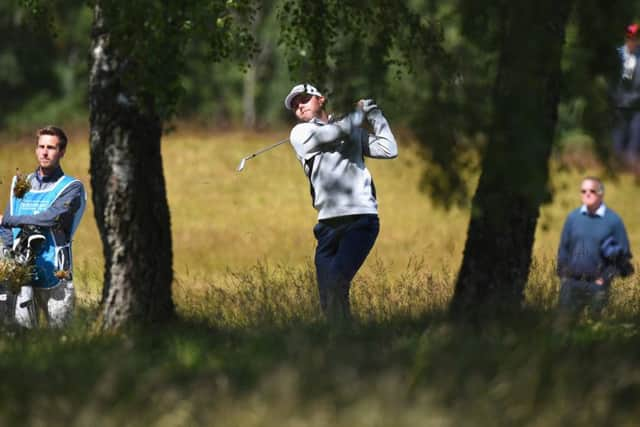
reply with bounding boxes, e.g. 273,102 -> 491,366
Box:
313,215 -> 380,321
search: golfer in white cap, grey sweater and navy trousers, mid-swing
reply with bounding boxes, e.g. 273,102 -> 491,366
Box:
284,84 -> 398,322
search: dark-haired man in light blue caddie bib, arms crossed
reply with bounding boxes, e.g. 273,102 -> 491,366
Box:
0,126 -> 86,327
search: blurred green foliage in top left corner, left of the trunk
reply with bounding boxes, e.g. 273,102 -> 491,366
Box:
0,0 -> 91,130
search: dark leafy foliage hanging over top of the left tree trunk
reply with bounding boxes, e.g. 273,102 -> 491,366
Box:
91,0 -> 255,119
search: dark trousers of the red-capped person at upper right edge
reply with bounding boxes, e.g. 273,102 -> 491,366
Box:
611,109 -> 640,167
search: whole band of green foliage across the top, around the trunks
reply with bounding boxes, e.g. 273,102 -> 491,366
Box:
5,0 -> 640,206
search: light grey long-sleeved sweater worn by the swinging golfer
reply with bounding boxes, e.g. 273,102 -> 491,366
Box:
290,109 -> 398,220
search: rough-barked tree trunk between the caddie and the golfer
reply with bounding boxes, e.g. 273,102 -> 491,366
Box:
89,2 -> 174,328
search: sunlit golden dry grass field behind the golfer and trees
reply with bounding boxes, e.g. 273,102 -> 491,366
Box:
0,130 -> 640,326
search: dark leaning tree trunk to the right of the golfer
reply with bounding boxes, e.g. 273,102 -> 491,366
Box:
452,0 -> 571,314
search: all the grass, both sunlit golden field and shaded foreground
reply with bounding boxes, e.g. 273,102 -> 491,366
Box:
0,131 -> 640,427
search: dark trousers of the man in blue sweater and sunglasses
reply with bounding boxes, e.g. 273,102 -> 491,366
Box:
558,278 -> 609,316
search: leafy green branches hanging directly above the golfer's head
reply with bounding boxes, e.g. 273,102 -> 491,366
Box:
278,0 -> 442,111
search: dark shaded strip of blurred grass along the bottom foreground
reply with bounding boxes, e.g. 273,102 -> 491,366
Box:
0,309 -> 640,426
